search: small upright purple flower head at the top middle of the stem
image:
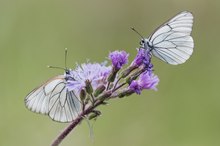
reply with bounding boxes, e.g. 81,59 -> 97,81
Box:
109,51 -> 129,70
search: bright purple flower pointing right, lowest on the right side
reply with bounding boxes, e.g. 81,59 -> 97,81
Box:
128,71 -> 159,94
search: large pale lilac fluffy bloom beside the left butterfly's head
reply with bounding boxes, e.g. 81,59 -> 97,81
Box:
67,63 -> 111,94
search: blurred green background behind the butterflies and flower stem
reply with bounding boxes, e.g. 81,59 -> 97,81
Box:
0,0 -> 220,146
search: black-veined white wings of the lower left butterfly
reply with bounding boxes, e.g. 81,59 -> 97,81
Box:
25,75 -> 81,122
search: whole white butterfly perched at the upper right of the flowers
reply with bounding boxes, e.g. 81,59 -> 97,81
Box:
132,11 -> 194,65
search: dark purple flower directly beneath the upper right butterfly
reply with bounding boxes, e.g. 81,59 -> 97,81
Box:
131,48 -> 152,67
